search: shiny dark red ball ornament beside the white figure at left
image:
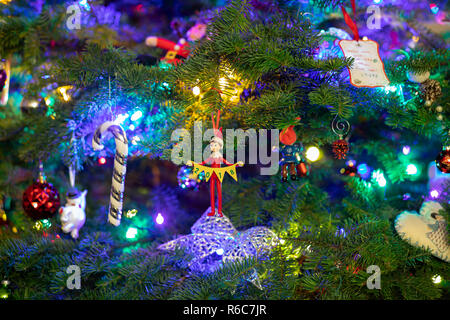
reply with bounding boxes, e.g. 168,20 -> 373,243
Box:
22,181 -> 61,220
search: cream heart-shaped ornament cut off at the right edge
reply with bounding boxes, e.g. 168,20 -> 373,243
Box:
395,201 -> 450,262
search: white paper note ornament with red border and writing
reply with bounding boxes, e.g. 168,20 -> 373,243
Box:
339,40 -> 389,88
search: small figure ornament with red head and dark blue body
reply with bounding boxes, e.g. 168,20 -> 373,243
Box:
280,117 -> 309,182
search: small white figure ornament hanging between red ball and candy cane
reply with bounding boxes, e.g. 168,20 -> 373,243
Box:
59,188 -> 87,239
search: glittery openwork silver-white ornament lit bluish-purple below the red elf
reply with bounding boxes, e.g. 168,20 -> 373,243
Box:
158,208 -> 278,272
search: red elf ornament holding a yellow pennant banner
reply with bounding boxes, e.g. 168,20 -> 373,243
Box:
187,110 -> 244,216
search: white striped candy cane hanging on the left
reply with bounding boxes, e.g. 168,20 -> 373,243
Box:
92,121 -> 128,227
